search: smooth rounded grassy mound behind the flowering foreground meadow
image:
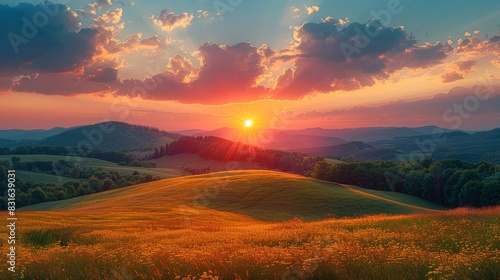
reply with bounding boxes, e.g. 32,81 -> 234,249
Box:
22,170 -> 444,221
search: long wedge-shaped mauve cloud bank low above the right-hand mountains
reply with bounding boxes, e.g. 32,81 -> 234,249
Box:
294,86 -> 500,129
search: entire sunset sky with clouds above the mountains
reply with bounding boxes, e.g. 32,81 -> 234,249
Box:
0,0 -> 500,131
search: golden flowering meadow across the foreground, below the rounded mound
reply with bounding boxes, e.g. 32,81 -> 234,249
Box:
0,207 -> 500,279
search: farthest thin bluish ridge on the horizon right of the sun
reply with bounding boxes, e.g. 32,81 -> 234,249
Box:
283,126 -> 460,142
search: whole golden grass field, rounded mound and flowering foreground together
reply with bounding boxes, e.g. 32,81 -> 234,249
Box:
0,170 -> 500,279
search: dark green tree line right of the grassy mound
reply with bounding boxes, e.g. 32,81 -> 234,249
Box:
311,158 -> 500,207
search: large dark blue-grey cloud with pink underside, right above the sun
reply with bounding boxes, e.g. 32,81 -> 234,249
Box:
273,19 -> 446,99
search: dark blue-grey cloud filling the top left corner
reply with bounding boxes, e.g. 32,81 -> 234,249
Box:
0,2 -> 98,76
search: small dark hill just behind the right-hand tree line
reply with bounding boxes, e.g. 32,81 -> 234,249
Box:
294,141 -> 398,160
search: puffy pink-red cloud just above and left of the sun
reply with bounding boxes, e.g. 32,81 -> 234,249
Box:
116,43 -> 269,104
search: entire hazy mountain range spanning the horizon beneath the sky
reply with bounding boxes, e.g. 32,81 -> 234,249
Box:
0,122 -> 500,162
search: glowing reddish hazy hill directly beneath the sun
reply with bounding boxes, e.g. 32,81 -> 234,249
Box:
194,127 -> 346,150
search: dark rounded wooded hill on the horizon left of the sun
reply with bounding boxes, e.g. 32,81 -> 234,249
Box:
40,122 -> 182,151
